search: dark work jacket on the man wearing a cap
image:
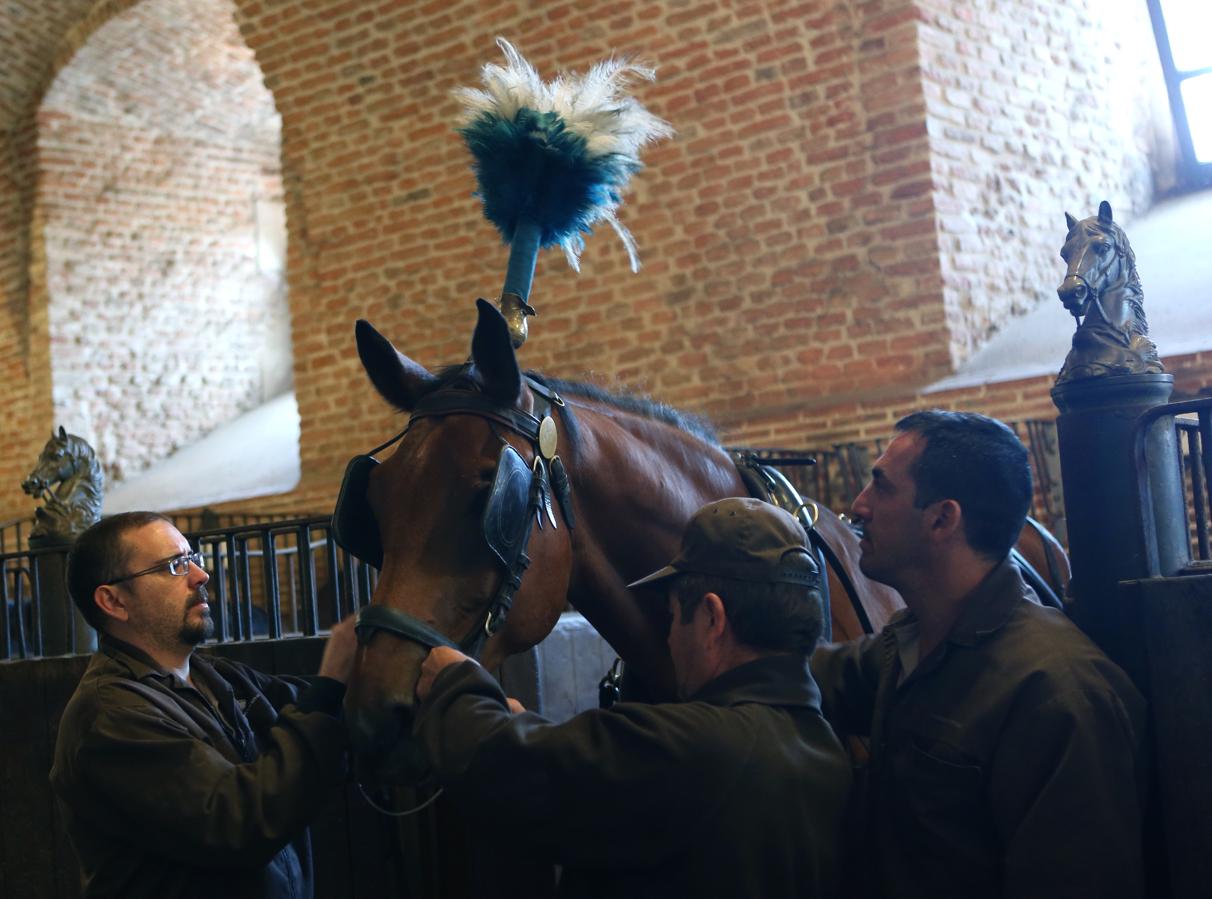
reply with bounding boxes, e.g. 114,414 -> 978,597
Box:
415,655 -> 850,899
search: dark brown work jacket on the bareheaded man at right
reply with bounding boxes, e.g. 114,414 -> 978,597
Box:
812,562 -> 1145,899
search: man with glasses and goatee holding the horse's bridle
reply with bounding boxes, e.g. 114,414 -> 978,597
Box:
51,513 -> 356,899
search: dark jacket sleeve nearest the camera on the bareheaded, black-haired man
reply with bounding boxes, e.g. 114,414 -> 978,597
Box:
989,689 -> 1144,899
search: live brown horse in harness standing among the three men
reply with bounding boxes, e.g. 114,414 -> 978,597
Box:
333,300 -> 1067,783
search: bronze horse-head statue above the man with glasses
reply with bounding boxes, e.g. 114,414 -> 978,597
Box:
21,426 -> 105,543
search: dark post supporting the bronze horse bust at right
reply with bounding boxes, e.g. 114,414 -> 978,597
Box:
1052,373 -> 1187,688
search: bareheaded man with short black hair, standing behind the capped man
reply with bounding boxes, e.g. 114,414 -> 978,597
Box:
812,411 -> 1145,899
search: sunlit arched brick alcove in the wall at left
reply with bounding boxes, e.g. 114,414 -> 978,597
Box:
34,0 -> 298,508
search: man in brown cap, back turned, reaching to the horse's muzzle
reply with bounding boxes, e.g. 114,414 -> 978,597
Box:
415,498 -> 850,898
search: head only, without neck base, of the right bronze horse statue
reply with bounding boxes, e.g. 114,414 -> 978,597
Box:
1057,200 -> 1138,327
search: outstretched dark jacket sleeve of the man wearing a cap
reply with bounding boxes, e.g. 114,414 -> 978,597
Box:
415,662 -> 754,866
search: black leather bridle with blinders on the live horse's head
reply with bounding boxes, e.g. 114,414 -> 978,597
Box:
332,377 -> 574,657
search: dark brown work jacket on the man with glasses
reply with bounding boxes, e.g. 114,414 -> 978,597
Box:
51,637 -> 345,899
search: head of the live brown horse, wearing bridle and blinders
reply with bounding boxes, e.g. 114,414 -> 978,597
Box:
344,300 -> 572,781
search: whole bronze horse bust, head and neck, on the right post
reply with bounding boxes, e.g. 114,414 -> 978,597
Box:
1057,200 -> 1164,384
